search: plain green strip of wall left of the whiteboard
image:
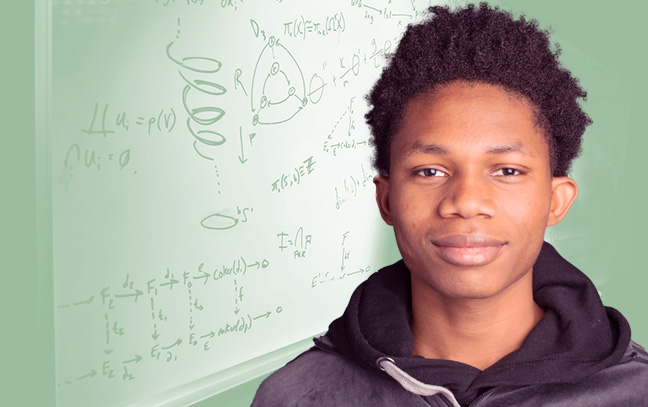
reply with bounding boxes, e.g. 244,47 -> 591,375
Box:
0,1 -> 54,406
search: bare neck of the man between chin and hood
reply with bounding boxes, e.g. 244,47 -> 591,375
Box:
410,273 -> 543,370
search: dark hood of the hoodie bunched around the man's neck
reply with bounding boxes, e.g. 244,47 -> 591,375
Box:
315,242 -> 630,405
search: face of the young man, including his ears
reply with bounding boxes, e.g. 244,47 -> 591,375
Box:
375,82 -> 577,299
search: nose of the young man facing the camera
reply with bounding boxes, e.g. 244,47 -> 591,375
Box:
439,174 -> 497,219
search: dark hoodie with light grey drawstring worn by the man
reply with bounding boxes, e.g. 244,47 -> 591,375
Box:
252,243 -> 648,407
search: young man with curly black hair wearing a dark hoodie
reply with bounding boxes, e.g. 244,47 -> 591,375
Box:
252,4 -> 648,407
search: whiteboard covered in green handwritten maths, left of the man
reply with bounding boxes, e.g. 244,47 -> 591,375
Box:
45,0 -> 460,407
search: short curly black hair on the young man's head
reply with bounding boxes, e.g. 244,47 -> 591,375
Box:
365,3 -> 592,177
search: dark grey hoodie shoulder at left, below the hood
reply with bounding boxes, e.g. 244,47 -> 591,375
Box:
252,347 -> 429,407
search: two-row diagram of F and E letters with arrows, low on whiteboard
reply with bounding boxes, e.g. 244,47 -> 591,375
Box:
57,256 -> 283,386
